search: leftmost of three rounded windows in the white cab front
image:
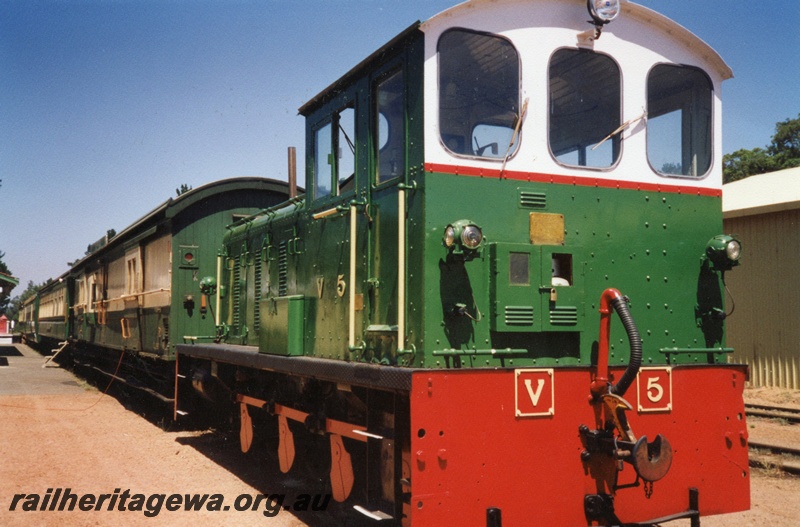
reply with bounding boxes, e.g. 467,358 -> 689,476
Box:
438,29 -> 520,159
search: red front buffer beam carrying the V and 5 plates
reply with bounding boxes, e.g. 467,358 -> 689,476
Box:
409,365 -> 750,527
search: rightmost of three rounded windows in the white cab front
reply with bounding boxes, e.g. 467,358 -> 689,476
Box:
647,64 -> 712,177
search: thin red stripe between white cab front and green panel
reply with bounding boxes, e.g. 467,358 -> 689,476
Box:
425,163 -> 722,198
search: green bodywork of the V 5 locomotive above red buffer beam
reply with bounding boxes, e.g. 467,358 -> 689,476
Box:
220,16 -> 726,376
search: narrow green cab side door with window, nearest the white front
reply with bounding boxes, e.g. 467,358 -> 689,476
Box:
366,68 -> 406,362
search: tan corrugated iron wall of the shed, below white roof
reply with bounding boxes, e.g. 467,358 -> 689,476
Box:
725,210 -> 800,390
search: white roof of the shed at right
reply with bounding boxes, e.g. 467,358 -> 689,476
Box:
722,167 -> 800,218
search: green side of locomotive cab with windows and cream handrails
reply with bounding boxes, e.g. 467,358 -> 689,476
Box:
297,26 -> 423,364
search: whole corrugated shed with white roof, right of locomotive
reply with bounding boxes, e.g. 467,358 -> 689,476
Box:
722,167 -> 800,390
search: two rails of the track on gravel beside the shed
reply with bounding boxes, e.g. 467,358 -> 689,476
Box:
745,404 -> 800,476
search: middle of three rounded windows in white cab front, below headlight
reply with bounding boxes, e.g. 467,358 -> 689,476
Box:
549,49 -> 622,168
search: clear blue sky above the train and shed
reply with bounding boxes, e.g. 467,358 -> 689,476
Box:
0,0 -> 800,293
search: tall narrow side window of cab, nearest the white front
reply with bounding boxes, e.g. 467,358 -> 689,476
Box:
375,71 -> 406,183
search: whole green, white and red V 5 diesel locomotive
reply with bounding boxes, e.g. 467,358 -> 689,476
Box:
176,0 -> 749,527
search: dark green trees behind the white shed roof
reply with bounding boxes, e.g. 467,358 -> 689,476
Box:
722,114 -> 800,183
